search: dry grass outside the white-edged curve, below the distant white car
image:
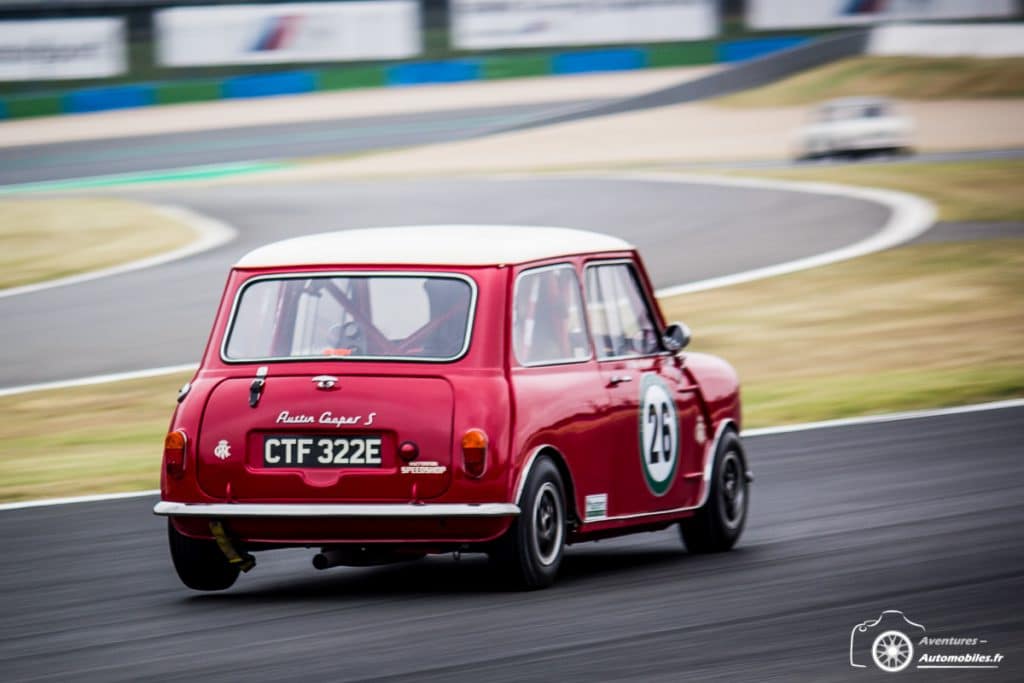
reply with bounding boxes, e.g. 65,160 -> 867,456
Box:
716,159 -> 1024,221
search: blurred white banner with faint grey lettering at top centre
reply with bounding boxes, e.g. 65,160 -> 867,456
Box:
450,0 -> 718,50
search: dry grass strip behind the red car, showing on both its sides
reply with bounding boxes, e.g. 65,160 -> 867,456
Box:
0,240 -> 1024,501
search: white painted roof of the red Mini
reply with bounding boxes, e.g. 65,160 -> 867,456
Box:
236,225 -> 633,268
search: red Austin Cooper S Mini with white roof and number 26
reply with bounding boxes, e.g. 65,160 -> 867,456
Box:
155,226 -> 751,591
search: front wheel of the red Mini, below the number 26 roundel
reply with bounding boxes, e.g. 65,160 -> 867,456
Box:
679,431 -> 751,553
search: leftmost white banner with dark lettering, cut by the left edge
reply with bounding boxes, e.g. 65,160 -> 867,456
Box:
0,18 -> 125,81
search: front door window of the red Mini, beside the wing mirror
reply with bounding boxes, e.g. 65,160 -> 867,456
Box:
586,263 -> 660,358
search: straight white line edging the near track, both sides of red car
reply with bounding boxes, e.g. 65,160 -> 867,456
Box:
0,398 -> 1024,512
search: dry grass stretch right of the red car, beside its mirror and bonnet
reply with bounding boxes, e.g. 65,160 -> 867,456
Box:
663,240 -> 1024,426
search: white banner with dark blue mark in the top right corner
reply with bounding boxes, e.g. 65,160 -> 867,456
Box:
746,0 -> 1017,30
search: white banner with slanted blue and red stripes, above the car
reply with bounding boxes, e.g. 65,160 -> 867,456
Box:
155,0 -> 421,67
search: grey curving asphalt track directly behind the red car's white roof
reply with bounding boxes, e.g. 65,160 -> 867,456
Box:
0,177 -> 889,387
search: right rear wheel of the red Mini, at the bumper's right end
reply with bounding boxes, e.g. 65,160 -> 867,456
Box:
490,457 -> 567,590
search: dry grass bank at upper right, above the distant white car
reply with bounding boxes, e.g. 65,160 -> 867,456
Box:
716,57 -> 1024,108
